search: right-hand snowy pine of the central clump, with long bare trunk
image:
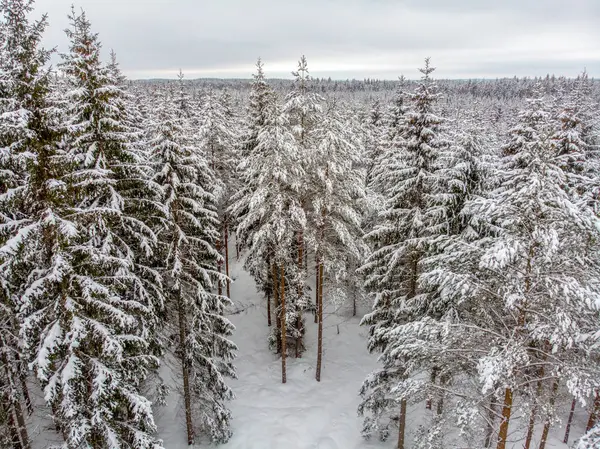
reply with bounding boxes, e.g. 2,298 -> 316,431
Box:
306,106 -> 367,381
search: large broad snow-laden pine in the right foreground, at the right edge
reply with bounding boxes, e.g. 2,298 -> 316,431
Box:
422,83 -> 598,449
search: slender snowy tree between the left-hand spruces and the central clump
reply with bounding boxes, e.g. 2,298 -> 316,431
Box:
198,90 -> 239,297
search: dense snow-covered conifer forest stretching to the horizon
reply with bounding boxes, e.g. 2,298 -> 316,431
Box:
0,0 -> 600,449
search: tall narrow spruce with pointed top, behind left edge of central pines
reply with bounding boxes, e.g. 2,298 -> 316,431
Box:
229,58 -> 275,326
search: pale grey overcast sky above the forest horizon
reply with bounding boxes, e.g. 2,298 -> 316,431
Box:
36,0 -> 600,79
